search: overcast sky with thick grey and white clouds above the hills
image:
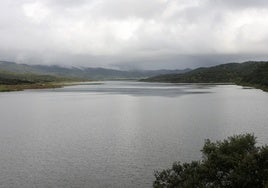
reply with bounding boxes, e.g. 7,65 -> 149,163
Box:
0,0 -> 268,69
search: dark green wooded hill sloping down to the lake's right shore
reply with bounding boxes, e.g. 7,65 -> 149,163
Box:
142,61 -> 268,90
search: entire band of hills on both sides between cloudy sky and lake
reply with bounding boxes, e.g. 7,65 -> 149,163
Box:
0,61 -> 268,90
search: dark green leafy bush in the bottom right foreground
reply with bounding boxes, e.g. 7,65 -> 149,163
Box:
153,134 -> 268,188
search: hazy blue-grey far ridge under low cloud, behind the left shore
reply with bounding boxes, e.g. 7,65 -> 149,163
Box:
0,61 -> 191,80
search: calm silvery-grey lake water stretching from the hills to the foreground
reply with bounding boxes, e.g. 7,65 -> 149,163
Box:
0,82 -> 268,188
